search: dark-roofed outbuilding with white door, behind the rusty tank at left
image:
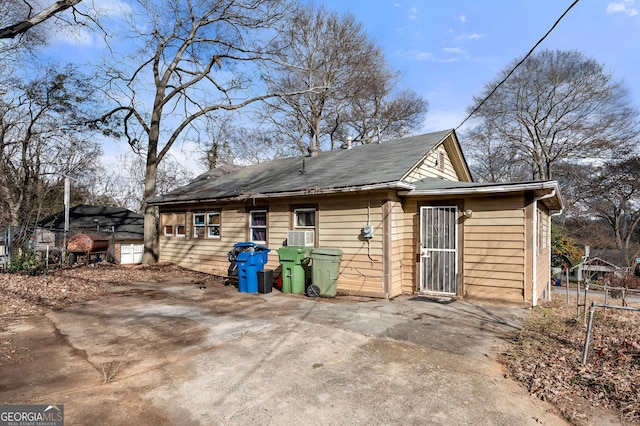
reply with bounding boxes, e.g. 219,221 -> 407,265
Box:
38,204 -> 144,265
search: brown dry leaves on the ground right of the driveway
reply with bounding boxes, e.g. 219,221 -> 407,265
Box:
503,297 -> 640,424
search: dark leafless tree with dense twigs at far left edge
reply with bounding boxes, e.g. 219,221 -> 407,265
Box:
0,63 -> 101,225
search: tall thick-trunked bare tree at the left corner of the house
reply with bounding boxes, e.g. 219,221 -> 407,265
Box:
95,0 -> 312,263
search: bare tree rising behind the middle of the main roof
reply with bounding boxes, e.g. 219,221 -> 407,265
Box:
263,5 -> 427,152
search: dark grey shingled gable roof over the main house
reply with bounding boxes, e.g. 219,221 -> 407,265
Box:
151,130 -> 453,204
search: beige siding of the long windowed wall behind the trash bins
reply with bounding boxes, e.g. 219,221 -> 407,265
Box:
160,194 -> 386,297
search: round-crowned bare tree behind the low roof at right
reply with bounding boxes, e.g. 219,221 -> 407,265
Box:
466,50 -> 638,180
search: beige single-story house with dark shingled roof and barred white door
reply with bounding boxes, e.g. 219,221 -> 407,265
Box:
151,130 -> 563,305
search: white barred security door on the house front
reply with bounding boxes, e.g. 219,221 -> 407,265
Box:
420,206 -> 458,295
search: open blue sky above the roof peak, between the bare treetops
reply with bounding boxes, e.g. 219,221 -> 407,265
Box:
317,0 -> 640,131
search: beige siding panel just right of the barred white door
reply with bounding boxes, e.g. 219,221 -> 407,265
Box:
463,197 -> 527,302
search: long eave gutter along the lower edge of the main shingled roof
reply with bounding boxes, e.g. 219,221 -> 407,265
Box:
149,181 -> 414,206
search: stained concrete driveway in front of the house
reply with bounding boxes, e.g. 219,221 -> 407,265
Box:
0,279 -> 566,425
